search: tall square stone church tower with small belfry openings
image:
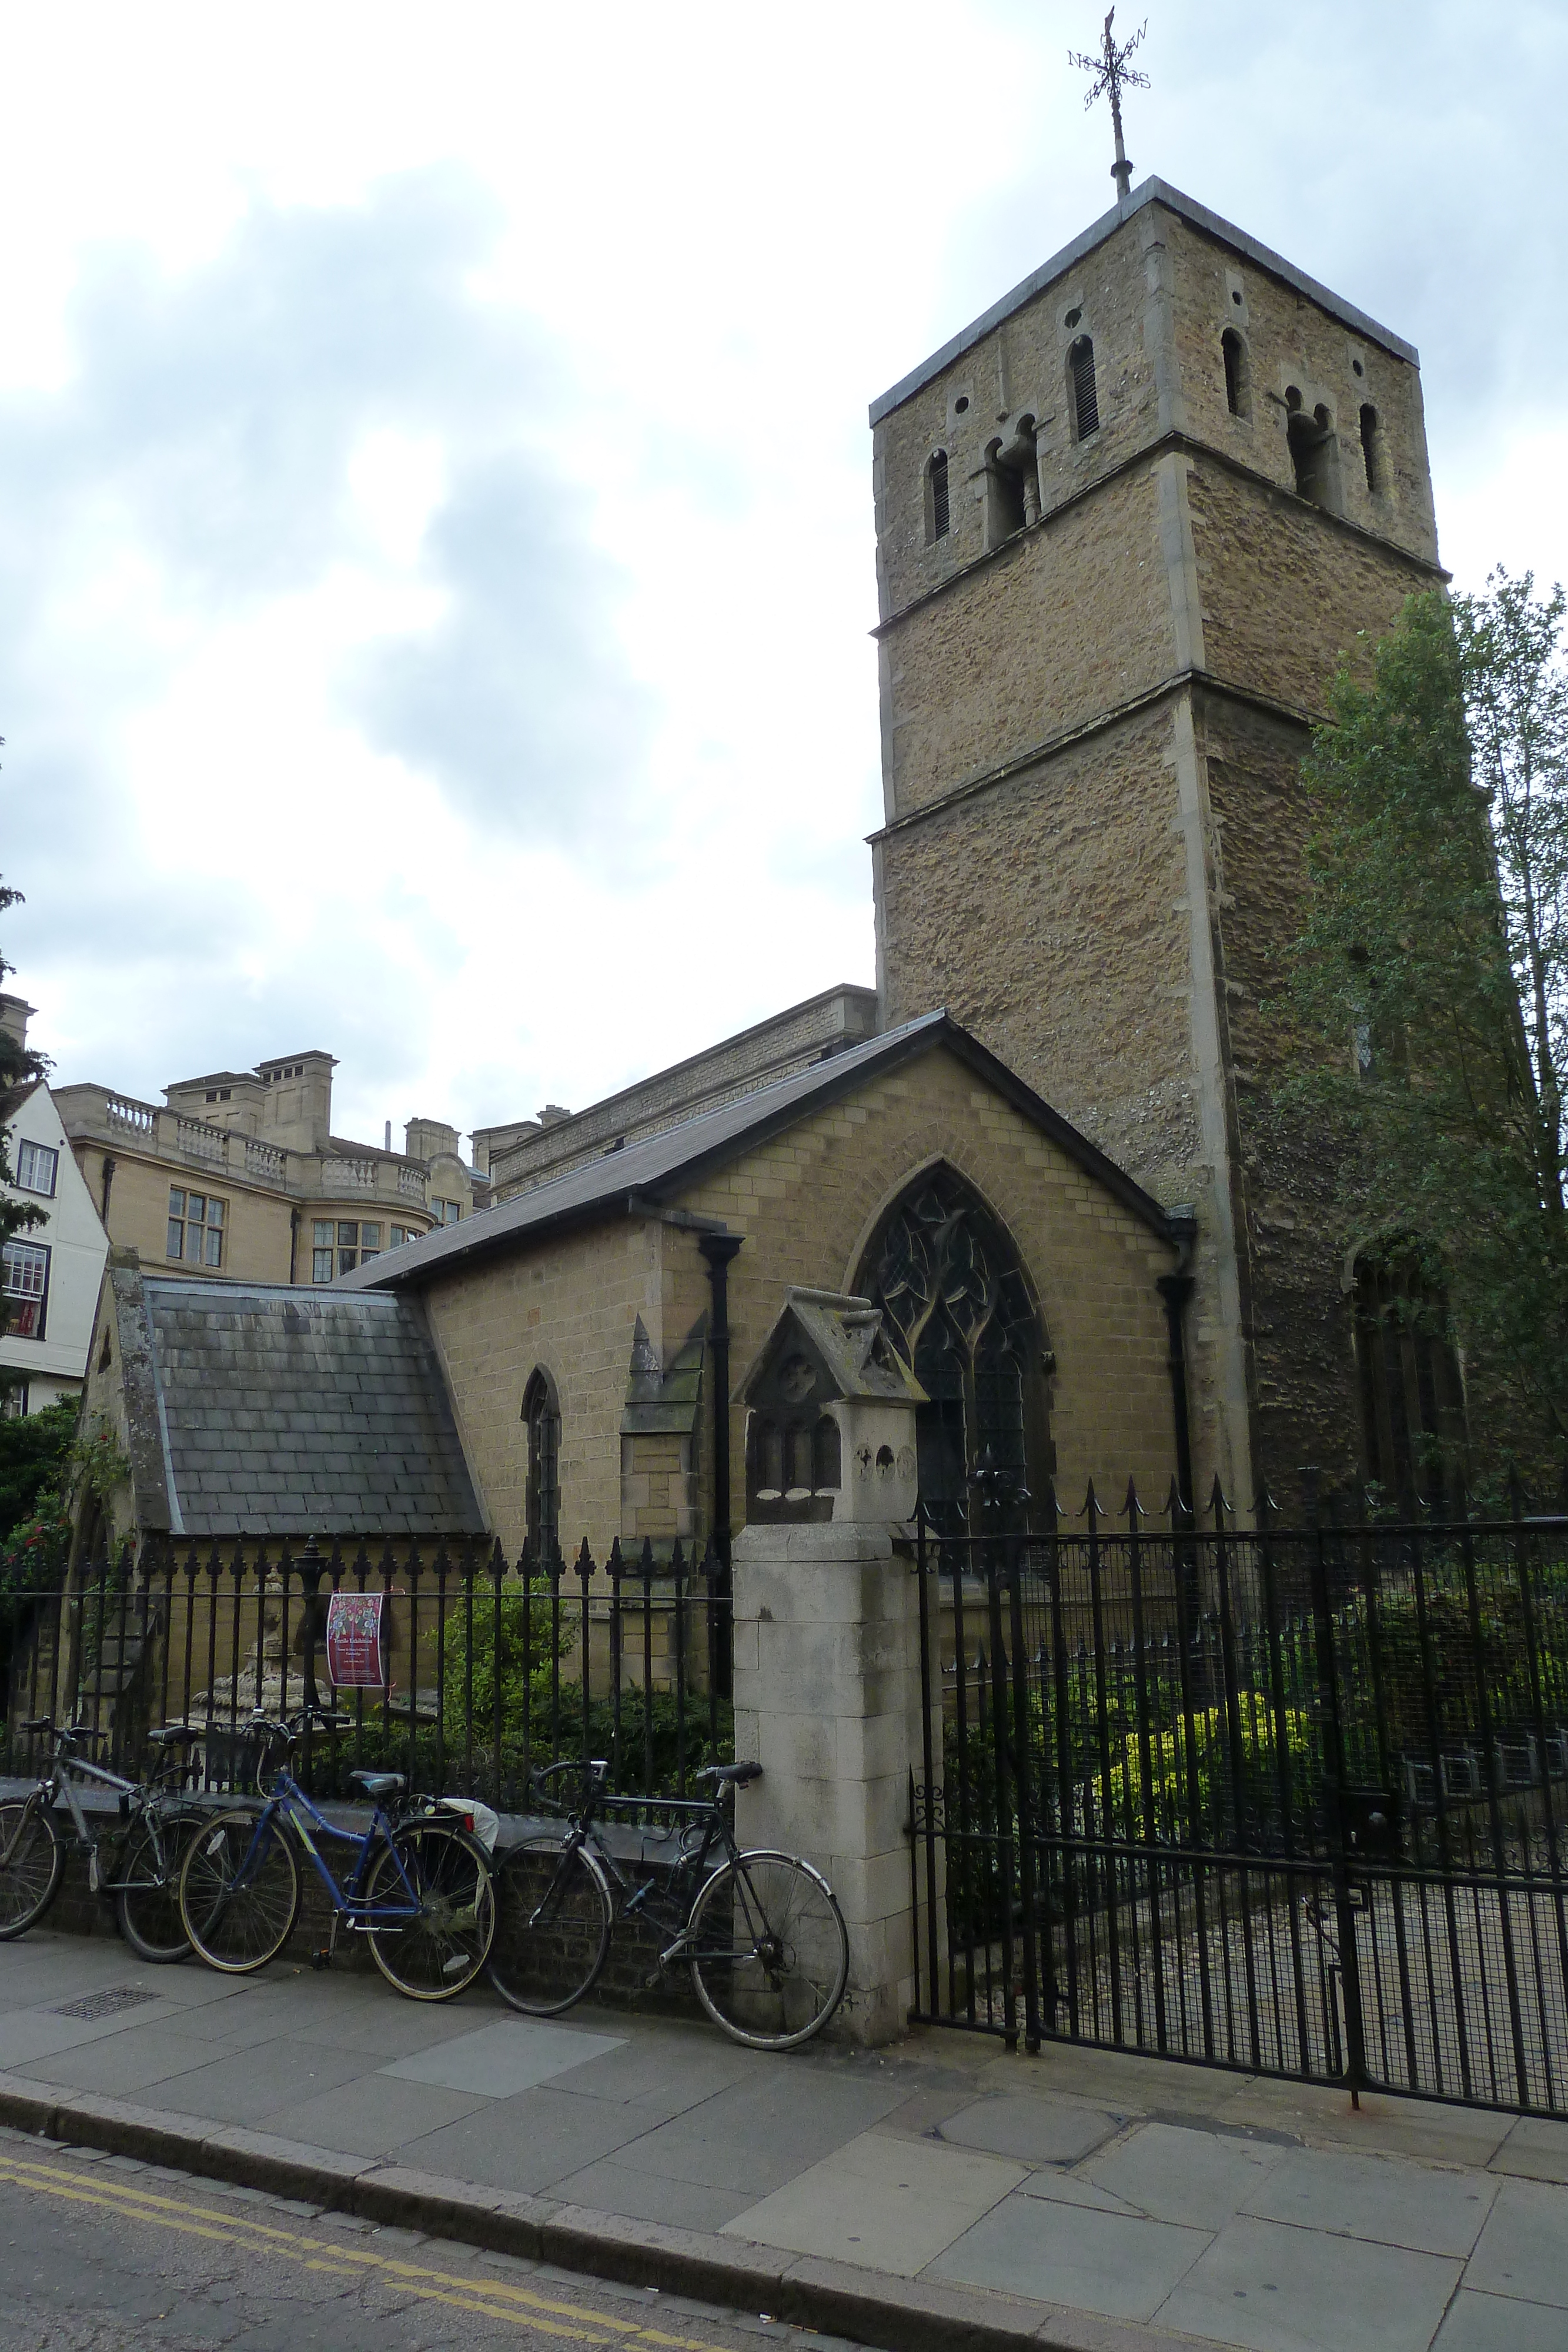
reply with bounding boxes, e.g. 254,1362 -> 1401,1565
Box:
872,179 -> 1443,1517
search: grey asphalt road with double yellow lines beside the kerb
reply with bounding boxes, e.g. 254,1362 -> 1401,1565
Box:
0,2131 -> 853,2352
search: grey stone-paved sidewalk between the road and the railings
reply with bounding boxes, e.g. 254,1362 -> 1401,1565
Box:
0,1931 -> 1568,2352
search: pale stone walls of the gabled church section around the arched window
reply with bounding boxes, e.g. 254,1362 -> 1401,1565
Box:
416,1051 -> 1175,1557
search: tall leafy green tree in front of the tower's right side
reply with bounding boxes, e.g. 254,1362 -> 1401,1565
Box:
1283,574 -> 1568,1461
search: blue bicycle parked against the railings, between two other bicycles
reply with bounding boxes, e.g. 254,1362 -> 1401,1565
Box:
179,1708 -> 496,2002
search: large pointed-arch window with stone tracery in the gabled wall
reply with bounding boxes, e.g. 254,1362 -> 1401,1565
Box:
855,1167 -> 1048,1534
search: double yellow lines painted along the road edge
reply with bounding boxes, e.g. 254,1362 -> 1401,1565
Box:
0,2152 -> 738,2352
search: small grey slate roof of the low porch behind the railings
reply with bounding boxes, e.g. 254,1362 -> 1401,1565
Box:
135,1277 -> 484,1538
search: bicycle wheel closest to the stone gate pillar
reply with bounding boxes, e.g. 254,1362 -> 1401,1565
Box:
689,1851 -> 848,2051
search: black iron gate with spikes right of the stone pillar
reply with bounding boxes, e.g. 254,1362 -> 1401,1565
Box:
910,1489 -> 1568,2114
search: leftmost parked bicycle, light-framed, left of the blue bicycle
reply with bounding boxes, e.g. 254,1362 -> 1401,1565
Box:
0,1715 -> 205,1962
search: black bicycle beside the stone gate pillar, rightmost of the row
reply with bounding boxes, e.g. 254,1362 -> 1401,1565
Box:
489,1759 -> 848,2051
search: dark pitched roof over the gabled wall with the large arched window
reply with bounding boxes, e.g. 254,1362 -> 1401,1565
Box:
332,1011 -> 1175,1294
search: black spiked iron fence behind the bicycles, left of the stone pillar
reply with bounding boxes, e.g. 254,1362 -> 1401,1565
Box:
0,1541 -> 734,1811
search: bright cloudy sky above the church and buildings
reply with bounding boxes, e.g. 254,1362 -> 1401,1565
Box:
0,0 -> 1568,1157
